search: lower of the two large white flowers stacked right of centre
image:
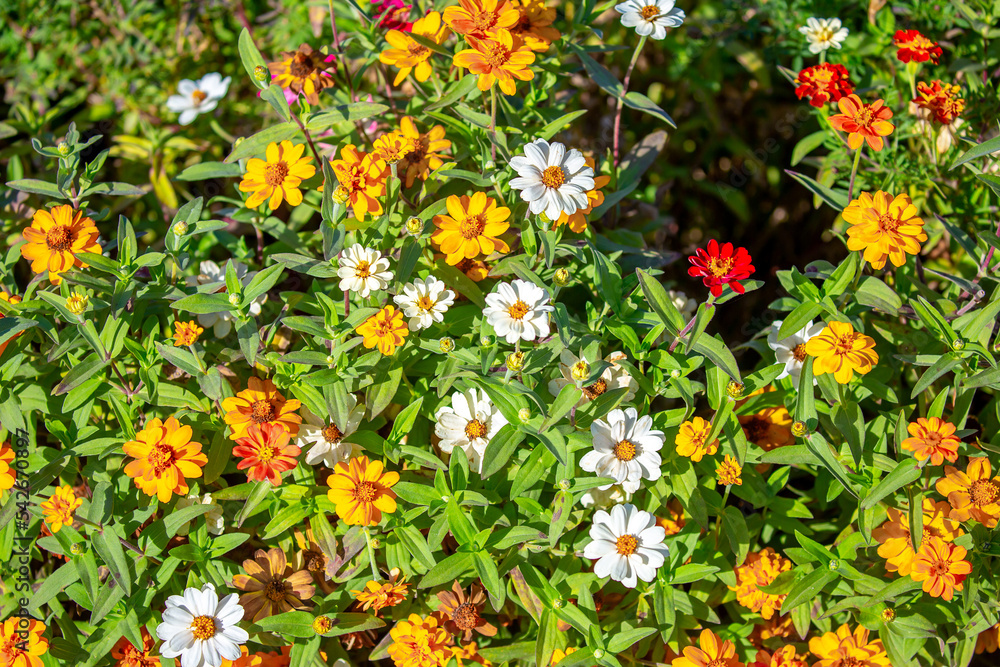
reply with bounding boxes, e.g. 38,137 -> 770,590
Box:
583,505 -> 670,588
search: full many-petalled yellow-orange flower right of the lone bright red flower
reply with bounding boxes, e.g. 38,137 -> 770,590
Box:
844,190 -> 927,269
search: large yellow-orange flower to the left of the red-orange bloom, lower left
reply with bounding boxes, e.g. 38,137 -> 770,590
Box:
122,417 -> 208,503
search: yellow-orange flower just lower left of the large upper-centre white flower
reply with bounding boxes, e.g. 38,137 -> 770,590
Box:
431,192 -> 510,266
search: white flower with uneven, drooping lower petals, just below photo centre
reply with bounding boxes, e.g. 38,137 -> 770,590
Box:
434,389 -> 507,473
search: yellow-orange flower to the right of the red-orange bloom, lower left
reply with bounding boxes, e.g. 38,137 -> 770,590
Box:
326,456 -> 399,526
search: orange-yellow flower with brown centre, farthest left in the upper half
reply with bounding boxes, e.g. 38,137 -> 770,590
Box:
21,204 -> 101,285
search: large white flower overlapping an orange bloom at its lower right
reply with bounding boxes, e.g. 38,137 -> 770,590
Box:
510,139 -> 594,221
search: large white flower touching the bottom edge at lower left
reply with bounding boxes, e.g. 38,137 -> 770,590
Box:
156,584 -> 250,667
